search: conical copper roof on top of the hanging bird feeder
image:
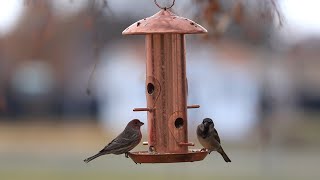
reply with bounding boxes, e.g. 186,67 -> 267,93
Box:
122,9 -> 207,35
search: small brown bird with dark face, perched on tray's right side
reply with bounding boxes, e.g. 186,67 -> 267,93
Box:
197,118 -> 231,162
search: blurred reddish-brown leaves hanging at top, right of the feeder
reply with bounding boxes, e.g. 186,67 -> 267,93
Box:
193,0 -> 283,44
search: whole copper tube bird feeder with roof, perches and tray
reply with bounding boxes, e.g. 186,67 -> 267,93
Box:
122,1 -> 208,163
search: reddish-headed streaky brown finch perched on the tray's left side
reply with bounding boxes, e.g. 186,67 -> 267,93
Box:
84,119 -> 144,163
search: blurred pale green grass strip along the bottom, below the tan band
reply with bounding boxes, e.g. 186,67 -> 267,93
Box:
0,151 -> 320,180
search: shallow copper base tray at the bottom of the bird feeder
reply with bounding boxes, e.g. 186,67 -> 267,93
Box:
128,150 -> 208,164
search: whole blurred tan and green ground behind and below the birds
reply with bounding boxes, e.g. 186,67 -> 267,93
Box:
0,118 -> 320,180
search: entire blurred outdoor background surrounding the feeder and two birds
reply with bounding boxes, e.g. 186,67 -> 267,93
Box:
0,0 -> 320,180
